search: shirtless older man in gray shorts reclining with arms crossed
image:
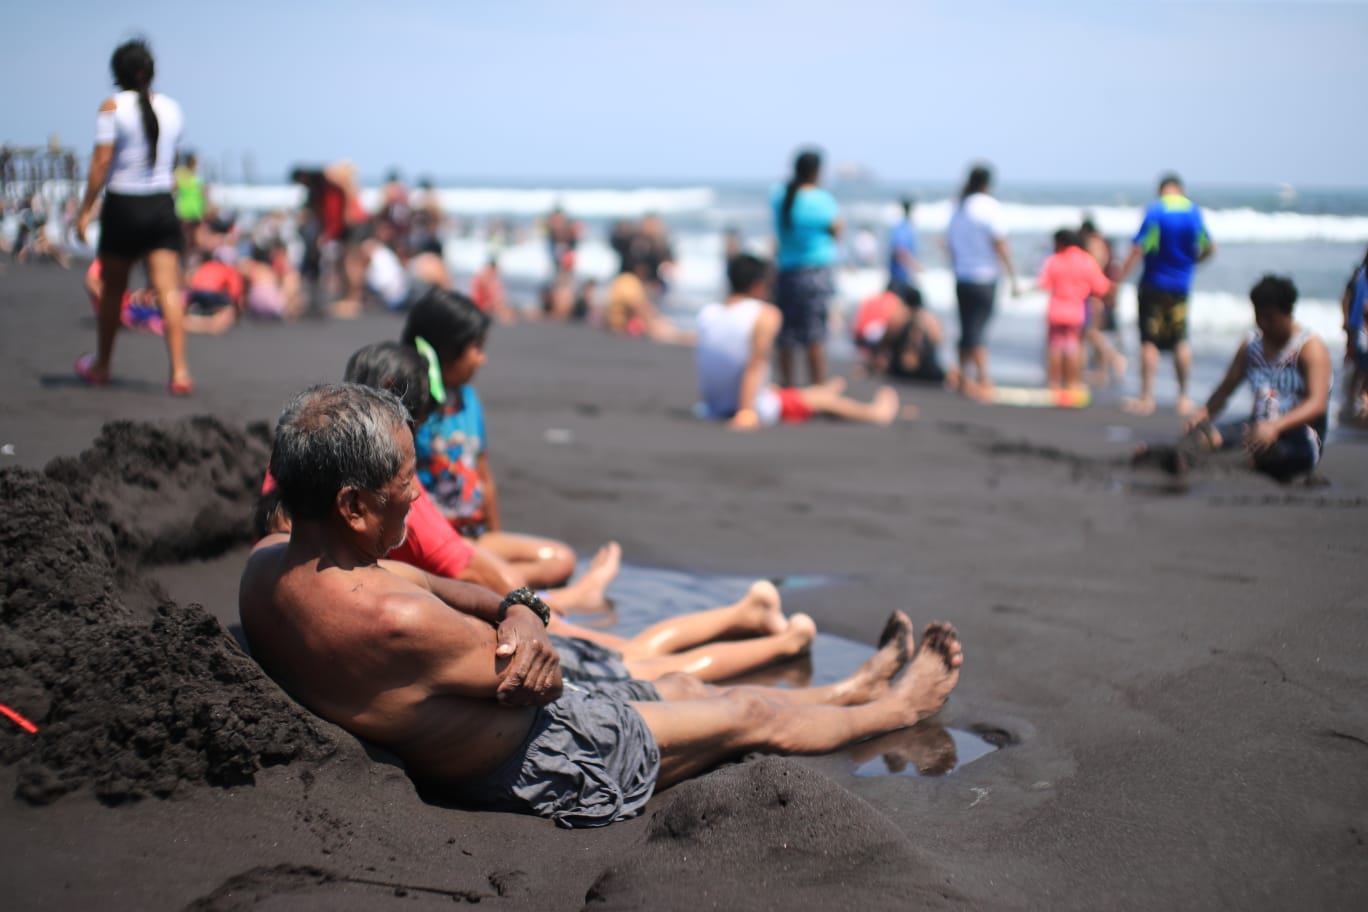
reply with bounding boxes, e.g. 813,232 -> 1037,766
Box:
239,384 -> 963,826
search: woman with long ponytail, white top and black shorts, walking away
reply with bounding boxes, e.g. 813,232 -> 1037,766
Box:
75,40 -> 194,395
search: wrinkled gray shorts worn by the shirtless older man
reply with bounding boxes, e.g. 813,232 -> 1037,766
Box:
442,691 -> 661,829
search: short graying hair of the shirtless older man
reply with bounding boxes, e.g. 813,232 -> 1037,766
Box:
271,383 -> 409,520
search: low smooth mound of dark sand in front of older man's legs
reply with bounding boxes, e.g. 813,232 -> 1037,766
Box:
586,757 -> 962,911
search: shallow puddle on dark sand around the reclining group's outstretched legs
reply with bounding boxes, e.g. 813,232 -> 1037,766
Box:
573,565 -> 1001,777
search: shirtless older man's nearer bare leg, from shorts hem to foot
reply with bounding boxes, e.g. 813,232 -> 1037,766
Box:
632,623 -> 963,788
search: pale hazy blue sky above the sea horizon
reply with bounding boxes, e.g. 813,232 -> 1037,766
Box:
10,0 -> 1368,186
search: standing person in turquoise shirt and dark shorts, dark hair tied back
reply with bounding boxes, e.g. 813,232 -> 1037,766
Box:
770,149 -> 843,387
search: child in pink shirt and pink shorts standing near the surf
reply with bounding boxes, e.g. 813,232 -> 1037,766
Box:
1038,228 -> 1111,390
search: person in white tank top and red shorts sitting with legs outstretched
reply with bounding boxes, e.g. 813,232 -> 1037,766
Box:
695,253 -> 910,431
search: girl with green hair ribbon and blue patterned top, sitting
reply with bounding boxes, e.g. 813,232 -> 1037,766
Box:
402,289 -> 604,588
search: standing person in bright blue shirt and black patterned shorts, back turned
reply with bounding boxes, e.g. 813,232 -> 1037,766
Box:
1116,174 -> 1216,414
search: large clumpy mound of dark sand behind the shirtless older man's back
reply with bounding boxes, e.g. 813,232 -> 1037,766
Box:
0,417 -> 338,804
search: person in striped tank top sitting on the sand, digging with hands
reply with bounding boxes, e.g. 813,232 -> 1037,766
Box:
1138,275 -> 1331,481
